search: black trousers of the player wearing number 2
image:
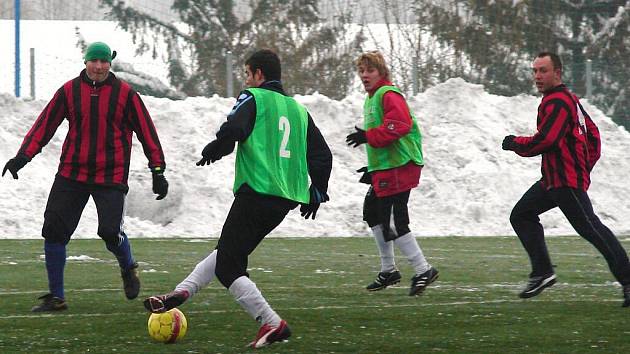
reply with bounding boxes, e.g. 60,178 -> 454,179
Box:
215,192 -> 297,288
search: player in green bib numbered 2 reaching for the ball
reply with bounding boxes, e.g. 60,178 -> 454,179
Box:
144,50 -> 332,348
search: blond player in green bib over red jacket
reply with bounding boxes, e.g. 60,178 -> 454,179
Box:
346,51 -> 438,296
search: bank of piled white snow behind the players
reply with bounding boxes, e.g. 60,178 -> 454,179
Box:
0,21 -> 630,238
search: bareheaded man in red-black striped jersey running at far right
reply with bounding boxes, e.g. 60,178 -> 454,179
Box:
503,52 -> 630,307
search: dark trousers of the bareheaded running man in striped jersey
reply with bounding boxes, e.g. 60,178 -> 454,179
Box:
510,182 -> 630,285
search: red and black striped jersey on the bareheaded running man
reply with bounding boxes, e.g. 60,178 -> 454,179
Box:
513,85 -> 601,191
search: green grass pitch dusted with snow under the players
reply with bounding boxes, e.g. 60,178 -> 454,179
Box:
0,237 -> 630,353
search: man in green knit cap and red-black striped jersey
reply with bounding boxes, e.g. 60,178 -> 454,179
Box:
2,42 -> 168,312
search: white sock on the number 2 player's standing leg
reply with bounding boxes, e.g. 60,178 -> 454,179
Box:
228,276 -> 282,327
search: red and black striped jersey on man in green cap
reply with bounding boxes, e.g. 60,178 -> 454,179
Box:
18,70 -> 165,187
